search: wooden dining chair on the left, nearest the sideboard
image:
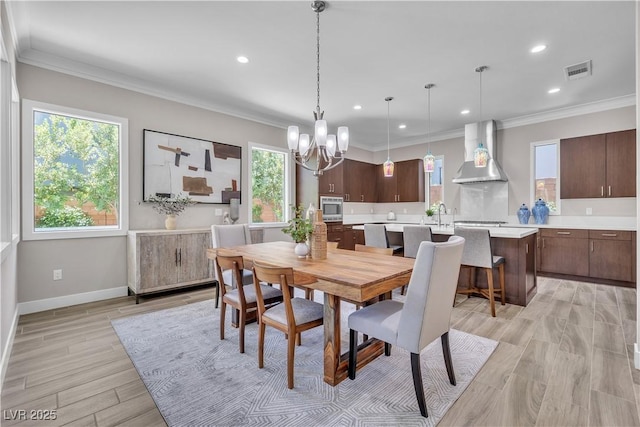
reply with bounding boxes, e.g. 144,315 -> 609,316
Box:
214,251 -> 282,353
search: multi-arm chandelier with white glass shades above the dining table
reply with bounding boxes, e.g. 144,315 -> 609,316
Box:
287,0 -> 349,176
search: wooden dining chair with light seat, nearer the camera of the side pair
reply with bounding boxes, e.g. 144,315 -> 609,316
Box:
253,260 -> 324,389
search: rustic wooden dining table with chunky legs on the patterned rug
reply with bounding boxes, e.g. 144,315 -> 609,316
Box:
207,242 -> 414,386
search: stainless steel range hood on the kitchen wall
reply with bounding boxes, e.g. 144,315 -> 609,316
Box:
453,120 -> 508,184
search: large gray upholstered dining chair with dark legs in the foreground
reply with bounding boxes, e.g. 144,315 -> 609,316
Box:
348,236 -> 465,417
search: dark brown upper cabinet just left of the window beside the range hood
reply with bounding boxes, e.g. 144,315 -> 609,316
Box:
376,159 -> 424,203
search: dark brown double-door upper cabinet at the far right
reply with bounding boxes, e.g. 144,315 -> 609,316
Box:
560,129 -> 636,199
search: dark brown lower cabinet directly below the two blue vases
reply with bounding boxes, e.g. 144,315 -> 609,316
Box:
539,228 -> 589,276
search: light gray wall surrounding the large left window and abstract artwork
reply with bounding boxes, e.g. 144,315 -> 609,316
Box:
17,64 -> 286,303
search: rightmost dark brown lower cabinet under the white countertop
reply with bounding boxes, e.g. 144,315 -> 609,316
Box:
589,230 -> 635,282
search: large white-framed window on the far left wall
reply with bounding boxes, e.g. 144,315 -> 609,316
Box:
23,100 -> 128,240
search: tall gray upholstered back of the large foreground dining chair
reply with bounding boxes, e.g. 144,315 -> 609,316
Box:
397,236 -> 465,354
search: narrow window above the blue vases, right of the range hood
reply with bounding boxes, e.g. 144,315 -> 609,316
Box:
531,140 -> 560,215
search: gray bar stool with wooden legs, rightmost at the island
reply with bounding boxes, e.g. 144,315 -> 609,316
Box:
454,227 -> 505,317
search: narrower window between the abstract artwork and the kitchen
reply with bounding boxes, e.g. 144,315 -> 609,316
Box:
249,144 -> 291,224
